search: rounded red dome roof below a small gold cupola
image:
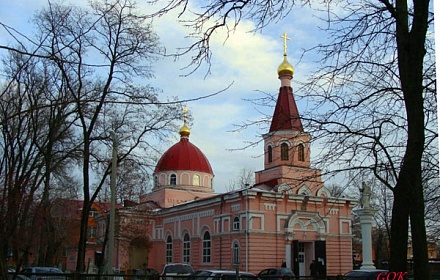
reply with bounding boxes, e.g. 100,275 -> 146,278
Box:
154,137 -> 213,174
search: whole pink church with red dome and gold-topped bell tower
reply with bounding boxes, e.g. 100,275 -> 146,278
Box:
98,35 -> 357,276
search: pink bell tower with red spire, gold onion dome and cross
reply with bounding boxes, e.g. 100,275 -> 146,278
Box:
255,33 -> 322,193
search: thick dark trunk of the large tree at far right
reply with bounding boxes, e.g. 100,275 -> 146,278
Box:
390,0 -> 430,280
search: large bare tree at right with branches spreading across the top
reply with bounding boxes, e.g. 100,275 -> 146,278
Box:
148,0 -> 437,279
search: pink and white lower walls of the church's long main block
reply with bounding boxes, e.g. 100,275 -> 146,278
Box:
121,190 -> 352,275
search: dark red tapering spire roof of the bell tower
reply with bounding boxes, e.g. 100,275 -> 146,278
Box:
269,87 -> 304,132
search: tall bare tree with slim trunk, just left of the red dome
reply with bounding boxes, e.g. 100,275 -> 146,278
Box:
26,0 -> 178,271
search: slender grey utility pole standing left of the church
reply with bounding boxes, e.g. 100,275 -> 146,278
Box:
107,131 -> 118,274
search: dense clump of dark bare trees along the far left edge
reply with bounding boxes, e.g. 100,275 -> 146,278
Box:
0,49 -> 76,277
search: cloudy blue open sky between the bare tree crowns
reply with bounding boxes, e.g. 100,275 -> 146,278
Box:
0,0 -> 438,193
